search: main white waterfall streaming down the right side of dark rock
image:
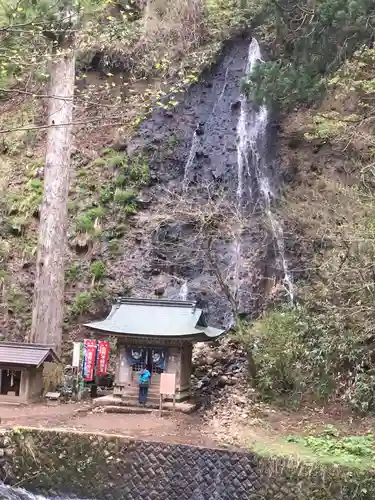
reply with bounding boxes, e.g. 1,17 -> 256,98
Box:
237,38 -> 294,303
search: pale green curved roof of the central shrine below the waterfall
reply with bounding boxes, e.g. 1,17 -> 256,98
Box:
85,298 -> 224,340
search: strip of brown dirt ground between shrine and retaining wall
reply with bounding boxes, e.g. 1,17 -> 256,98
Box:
0,401 -> 375,448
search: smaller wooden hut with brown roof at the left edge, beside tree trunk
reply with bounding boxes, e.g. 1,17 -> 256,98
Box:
0,342 -> 59,403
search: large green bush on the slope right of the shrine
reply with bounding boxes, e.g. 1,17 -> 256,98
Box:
238,300 -> 375,411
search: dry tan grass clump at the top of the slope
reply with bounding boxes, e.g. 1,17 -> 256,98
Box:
85,0 -> 235,78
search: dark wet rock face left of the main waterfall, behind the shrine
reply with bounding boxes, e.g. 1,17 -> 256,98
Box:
110,39 -> 274,326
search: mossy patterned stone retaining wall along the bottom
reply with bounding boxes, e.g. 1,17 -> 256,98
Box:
0,429 -> 375,500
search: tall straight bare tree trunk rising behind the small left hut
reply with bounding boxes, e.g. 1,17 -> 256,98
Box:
31,41 -> 75,353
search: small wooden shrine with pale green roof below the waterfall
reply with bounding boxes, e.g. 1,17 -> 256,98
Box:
85,298 -> 224,401
